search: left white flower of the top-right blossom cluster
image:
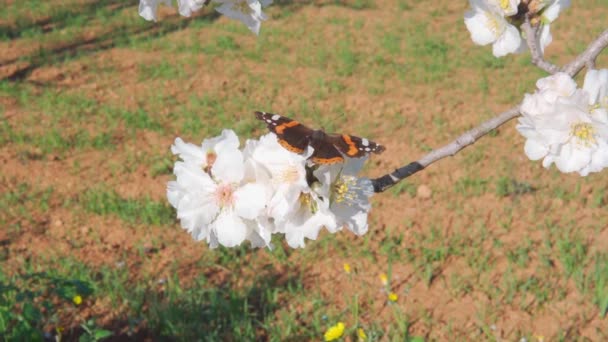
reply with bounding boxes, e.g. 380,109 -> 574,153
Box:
464,0 -> 525,57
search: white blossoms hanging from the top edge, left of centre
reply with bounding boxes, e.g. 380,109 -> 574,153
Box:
139,0 -> 272,34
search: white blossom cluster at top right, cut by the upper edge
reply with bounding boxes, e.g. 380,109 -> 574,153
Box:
464,0 -> 570,57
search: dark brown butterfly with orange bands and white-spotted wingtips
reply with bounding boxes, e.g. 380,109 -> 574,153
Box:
255,112 -> 385,164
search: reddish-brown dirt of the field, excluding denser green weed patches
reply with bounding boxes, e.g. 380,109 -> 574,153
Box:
0,0 -> 608,341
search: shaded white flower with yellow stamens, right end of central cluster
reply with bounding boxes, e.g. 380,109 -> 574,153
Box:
314,158 -> 374,235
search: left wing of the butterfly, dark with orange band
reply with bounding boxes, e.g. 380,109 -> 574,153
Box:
255,112 -> 312,153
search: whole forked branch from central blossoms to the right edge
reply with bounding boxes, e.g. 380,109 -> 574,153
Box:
372,26 -> 608,192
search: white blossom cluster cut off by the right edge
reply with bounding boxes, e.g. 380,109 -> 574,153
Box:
517,69 -> 608,176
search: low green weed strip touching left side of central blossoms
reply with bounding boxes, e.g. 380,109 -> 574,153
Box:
78,188 -> 175,225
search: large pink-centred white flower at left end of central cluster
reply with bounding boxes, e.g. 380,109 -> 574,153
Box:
167,131 -> 270,248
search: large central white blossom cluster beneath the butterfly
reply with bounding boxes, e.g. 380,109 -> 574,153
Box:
167,130 -> 374,248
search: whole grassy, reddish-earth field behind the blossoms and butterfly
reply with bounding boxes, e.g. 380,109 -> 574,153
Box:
0,0 -> 608,341
